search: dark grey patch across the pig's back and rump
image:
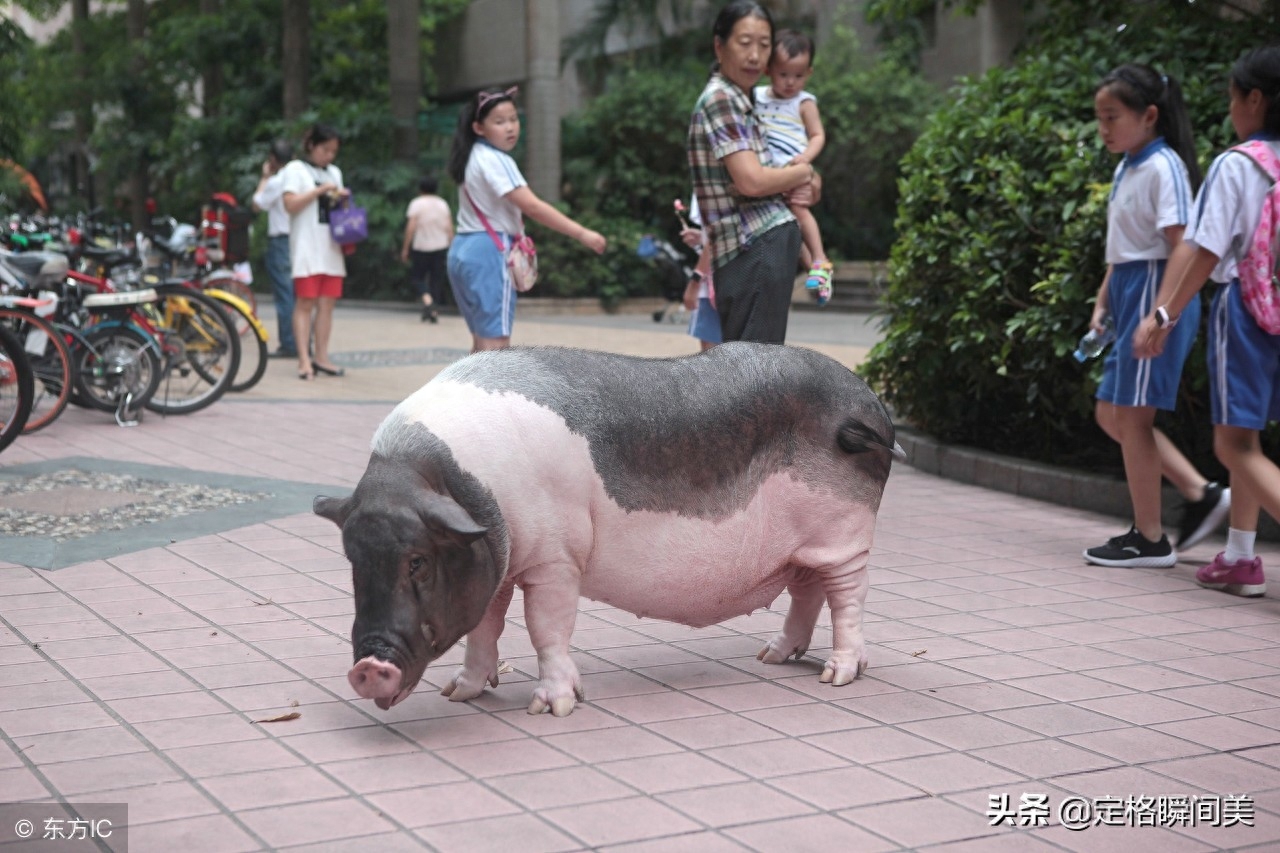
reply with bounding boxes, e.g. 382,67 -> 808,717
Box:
438,343 -> 893,519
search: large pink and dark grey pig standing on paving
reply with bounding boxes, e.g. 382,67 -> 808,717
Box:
315,343 -> 901,716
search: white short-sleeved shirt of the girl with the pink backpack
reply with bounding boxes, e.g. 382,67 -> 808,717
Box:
1183,140 -> 1280,284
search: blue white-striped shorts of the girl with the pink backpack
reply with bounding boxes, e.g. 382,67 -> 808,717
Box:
1208,279 -> 1280,430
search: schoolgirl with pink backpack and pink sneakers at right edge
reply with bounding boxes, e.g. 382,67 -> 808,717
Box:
1133,46 -> 1280,596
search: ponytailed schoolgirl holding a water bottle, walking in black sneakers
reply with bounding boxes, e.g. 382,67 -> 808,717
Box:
1084,65 -> 1230,567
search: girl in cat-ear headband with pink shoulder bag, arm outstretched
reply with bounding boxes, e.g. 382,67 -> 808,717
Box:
449,87 -> 604,352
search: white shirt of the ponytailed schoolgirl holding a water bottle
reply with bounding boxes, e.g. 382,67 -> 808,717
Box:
1107,137 -> 1192,264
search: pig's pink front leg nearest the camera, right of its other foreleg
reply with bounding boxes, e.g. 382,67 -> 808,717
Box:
520,565 -> 585,717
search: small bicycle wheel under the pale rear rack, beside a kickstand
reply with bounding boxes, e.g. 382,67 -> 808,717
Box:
73,323 -> 161,411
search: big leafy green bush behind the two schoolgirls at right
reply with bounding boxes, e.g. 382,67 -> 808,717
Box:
865,1 -> 1258,467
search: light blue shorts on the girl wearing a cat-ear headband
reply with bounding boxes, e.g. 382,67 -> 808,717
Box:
449,231 -> 516,338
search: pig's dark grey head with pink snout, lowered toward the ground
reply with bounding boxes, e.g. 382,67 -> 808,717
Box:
314,453 -> 504,710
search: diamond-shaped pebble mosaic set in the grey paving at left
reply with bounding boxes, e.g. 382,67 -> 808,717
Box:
0,469 -> 273,542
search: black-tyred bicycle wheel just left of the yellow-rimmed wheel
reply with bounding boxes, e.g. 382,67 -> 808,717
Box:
147,286 -> 241,415
